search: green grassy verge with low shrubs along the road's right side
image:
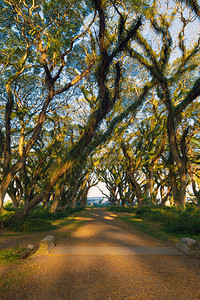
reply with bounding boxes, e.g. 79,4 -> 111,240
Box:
109,206 -> 200,242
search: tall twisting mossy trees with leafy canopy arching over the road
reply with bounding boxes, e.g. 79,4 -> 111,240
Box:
0,0 -> 200,222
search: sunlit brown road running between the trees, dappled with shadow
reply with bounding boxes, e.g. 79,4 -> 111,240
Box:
0,209 -> 200,300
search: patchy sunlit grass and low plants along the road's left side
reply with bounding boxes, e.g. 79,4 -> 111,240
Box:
0,209 -> 87,265
